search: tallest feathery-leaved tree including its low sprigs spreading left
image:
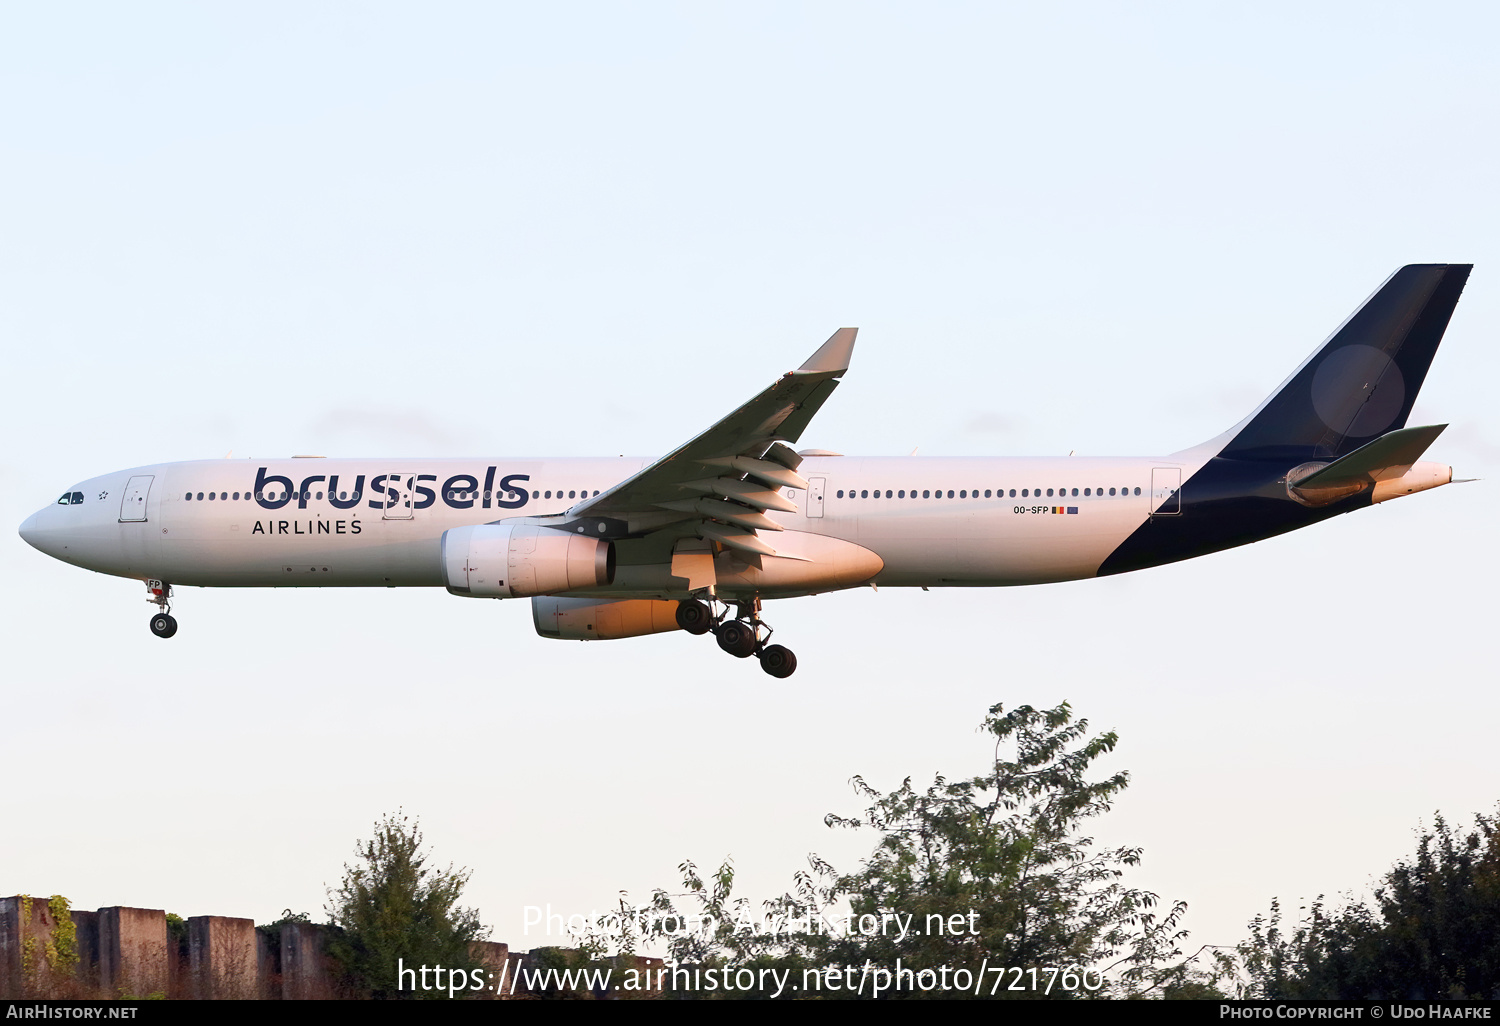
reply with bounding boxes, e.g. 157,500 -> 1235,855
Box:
609,704 -> 1223,998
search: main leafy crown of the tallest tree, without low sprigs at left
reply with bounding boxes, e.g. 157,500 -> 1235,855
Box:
828,704 -> 1185,981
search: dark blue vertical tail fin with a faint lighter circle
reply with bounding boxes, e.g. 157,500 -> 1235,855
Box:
1220,264 -> 1473,461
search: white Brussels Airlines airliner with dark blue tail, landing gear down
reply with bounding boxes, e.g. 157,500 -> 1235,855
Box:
21,264 -> 1472,678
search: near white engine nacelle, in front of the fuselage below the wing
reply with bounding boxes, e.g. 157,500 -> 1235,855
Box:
443,522 -> 615,599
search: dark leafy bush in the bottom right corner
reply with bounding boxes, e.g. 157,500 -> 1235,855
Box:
1241,815 -> 1500,1001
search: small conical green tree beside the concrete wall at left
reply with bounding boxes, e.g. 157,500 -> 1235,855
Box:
327,812 -> 488,998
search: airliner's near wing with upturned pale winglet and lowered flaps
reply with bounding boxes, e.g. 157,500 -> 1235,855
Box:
567,329 -> 858,555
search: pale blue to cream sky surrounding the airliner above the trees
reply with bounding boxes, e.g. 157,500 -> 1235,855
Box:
0,3 -> 1500,972
